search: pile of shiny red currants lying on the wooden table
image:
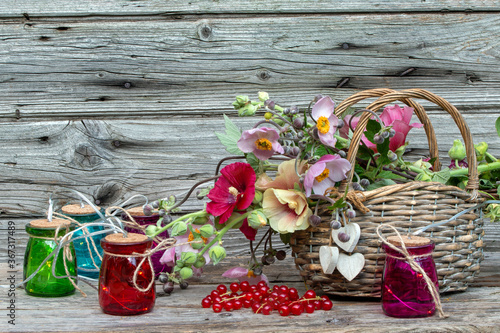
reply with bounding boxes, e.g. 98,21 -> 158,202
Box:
201,281 -> 333,316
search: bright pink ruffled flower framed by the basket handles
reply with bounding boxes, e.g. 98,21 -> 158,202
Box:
380,104 -> 423,151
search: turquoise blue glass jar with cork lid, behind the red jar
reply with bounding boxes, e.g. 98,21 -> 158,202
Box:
61,204 -> 106,279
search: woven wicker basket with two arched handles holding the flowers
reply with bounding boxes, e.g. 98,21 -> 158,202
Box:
291,89 -> 484,297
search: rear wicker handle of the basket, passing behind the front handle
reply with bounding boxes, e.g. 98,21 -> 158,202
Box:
335,88 -> 441,171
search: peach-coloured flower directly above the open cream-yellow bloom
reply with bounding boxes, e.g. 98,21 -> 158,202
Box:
255,160 -> 307,191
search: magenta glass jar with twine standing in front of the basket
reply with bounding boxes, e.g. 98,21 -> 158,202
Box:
382,236 -> 439,318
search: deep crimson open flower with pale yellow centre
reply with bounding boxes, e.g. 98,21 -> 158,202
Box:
207,162 -> 256,224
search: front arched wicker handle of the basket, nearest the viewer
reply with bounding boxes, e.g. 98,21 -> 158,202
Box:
340,89 -> 479,191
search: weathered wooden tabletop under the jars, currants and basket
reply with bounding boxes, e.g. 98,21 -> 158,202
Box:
0,254 -> 500,332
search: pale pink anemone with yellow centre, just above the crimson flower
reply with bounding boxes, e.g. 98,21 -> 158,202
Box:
238,127 -> 284,161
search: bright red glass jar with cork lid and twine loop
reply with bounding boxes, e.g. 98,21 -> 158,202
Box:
99,233 -> 156,316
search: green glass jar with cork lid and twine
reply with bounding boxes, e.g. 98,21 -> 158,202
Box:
23,219 -> 76,297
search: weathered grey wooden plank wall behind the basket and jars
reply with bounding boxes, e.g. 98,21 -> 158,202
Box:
0,0 -> 500,266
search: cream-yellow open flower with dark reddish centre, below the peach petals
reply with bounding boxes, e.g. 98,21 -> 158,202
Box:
262,188 -> 312,234
